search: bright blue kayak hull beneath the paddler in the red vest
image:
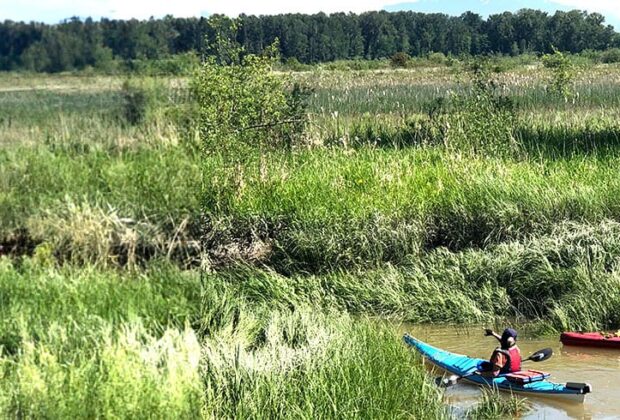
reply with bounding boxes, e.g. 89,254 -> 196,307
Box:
404,334 -> 592,403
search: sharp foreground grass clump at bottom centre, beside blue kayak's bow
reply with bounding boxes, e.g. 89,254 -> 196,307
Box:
199,315 -> 444,418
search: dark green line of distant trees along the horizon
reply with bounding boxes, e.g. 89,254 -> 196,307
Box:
0,9 -> 620,72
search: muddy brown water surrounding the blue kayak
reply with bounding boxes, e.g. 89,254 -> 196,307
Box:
401,325 -> 620,419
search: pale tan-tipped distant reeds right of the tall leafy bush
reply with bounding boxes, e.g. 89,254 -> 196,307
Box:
298,67 -> 620,118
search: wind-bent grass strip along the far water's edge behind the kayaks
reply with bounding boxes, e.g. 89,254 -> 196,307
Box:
207,221 -> 620,332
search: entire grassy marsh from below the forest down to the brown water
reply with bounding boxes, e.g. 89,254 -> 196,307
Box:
0,58 -> 620,418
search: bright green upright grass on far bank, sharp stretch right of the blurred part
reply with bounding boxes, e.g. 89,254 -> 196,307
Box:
206,148 -> 620,272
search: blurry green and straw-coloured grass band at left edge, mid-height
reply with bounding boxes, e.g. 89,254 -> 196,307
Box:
0,146 -> 201,262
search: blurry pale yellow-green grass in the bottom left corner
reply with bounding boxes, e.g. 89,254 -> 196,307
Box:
0,326 -> 204,418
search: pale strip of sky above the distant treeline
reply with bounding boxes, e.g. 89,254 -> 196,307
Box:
0,0 -> 620,30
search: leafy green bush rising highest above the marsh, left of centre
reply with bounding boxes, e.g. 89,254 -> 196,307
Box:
192,20 -> 309,153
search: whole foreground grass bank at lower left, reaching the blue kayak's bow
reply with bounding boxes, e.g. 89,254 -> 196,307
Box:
0,259 -> 445,418
